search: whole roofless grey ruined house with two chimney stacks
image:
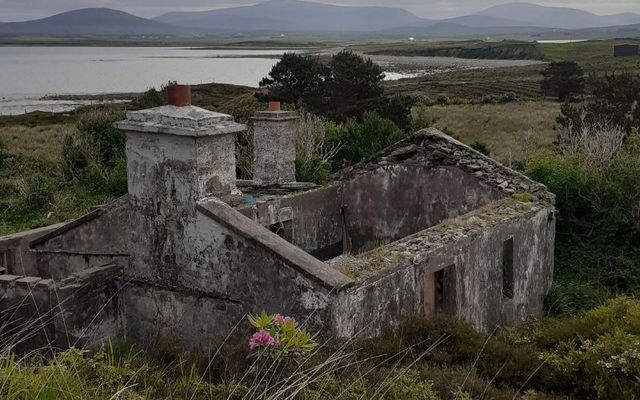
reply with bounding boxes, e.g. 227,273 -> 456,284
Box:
0,88 -> 555,349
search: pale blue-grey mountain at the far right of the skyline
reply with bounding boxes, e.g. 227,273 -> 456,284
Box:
474,3 -> 640,29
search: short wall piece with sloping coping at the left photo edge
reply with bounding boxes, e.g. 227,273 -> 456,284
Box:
0,224 -> 64,276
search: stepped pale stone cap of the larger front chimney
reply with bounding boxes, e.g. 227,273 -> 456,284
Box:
114,106 -> 247,137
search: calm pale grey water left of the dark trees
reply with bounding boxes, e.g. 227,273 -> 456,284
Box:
0,46 -> 284,115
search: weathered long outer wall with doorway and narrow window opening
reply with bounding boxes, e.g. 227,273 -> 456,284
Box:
333,202 -> 555,336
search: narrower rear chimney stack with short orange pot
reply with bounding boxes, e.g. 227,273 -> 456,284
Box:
252,102 -> 299,185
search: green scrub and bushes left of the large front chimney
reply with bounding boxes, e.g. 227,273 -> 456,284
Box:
0,111 -> 126,235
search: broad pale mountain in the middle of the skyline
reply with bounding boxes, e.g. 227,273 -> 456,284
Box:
155,0 -> 432,32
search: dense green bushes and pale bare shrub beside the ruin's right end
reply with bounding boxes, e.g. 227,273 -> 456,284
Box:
526,75 -> 640,314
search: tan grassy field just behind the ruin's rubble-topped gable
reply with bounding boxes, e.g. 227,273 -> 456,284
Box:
416,101 -> 560,165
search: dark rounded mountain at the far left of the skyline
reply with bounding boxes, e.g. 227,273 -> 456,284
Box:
0,8 -> 188,36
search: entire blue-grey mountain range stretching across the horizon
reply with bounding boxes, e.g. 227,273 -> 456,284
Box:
0,0 -> 640,38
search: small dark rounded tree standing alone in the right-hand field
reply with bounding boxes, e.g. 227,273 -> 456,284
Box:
542,61 -> 585,101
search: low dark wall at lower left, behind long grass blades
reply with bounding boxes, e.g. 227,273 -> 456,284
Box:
0,265 -> 122,354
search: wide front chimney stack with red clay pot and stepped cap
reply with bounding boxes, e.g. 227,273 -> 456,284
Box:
116,85 -> 246,209
